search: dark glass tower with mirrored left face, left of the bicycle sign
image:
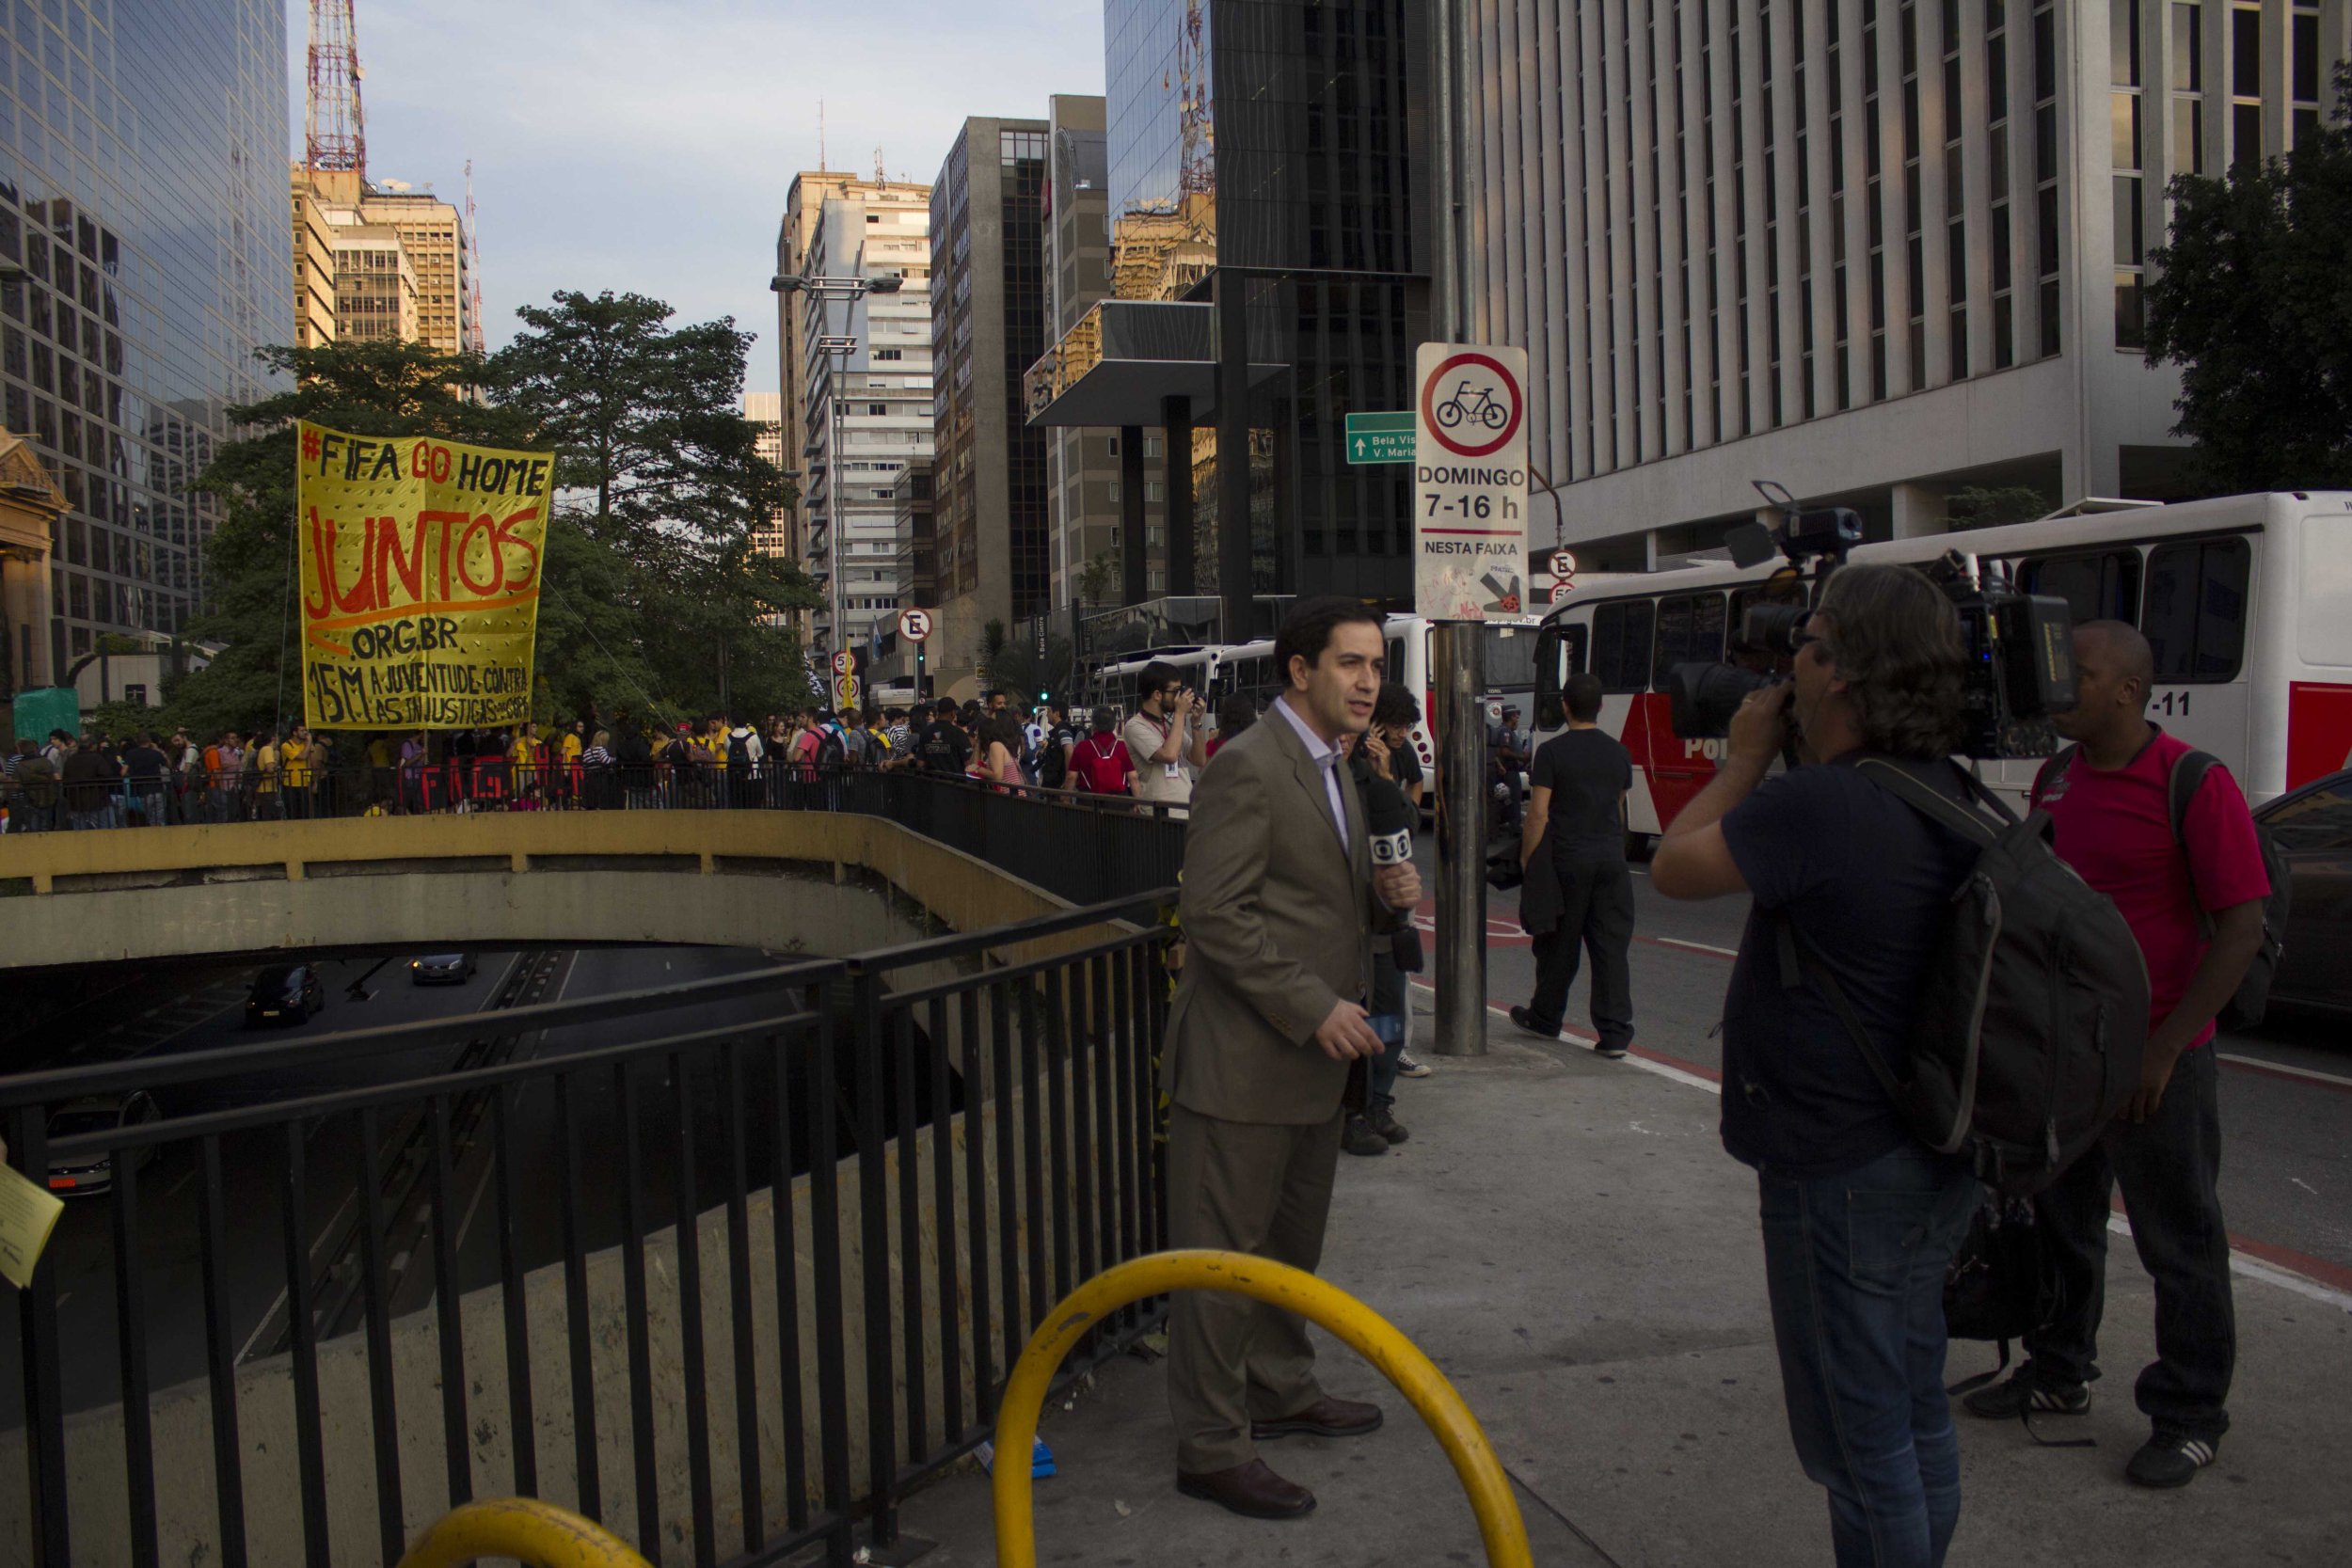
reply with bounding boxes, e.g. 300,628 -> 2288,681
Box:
1104,0 -> 1430,604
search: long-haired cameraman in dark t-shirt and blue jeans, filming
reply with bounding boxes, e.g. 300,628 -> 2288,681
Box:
1651,566 -> 1980,1568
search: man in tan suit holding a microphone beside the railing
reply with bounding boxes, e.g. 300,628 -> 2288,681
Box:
1162,599 -> 1421,1519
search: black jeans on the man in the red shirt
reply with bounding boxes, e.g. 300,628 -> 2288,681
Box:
2026,1046 -> 2237,1439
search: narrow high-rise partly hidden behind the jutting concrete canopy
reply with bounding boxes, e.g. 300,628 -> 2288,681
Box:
1044,94 -> 1165,613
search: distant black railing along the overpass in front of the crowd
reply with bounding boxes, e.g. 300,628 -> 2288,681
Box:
12,759 -> 1184,903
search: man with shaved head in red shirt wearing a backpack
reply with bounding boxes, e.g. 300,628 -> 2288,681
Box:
1966,621 -> 2270,1486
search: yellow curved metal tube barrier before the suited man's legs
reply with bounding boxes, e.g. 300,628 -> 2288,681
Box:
993,1248 -> 1534,1568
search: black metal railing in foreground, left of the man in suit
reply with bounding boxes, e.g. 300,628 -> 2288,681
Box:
0,889 -> 1171,1568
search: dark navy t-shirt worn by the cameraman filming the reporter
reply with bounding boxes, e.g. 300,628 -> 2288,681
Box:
1724,764 -> 1976,1180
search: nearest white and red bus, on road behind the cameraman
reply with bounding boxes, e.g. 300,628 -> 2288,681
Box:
1536,491 -> 2352,834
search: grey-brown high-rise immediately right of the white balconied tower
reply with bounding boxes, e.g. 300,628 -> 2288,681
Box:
930,118 -> 1052,691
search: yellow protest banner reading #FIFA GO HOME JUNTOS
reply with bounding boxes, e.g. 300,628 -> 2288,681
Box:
294,420 -> 555,729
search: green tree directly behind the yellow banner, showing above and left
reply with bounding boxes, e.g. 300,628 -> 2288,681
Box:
165,343 -> 532,736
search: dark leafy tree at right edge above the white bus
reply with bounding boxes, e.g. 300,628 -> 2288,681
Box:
2148,63 -> 2352,494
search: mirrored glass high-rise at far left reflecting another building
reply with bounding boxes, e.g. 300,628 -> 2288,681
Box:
0,0 -> 296,679
